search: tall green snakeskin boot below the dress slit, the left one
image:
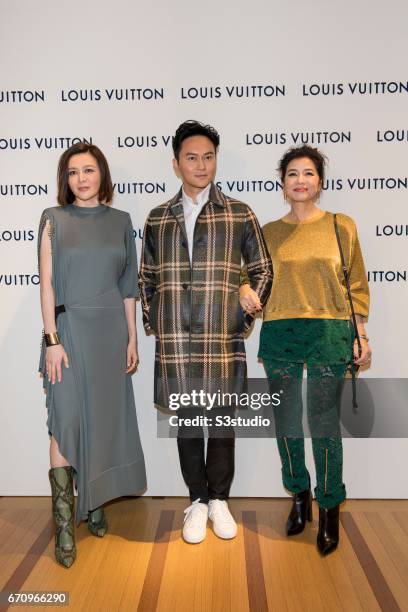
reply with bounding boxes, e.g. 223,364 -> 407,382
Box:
48,466 -> 76,567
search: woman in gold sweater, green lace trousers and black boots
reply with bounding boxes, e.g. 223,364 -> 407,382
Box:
240,146 -> 371,555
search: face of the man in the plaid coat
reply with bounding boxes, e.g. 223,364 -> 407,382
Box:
173,136 -> 217,192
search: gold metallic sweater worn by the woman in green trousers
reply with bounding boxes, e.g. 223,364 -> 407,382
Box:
243,212 -> 370,321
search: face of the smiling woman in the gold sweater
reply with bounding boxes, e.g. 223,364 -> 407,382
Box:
283,157 -> 321,203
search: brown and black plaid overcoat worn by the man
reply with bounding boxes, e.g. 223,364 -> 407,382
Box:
139,184 -> 272,408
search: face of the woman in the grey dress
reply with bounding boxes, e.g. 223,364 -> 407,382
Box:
68,153 -> 101,206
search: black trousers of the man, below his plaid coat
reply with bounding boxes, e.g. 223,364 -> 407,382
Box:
177,408 -> 235,504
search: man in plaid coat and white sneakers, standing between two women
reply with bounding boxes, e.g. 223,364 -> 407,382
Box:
139,121 -> 272,543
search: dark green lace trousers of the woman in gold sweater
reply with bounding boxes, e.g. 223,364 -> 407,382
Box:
264,357 -> 346,508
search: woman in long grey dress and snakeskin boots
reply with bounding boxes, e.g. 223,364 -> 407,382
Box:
38,143 -> 146,567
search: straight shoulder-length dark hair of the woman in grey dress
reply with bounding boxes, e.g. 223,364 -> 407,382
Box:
57,142 -> 113,206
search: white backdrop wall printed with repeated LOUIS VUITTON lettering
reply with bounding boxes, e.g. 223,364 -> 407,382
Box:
0,0 -> 408,498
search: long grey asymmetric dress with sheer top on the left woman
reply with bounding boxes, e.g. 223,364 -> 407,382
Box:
39,204 -> 146,522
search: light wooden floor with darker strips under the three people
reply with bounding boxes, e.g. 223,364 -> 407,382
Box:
0,497 -> 408,612
